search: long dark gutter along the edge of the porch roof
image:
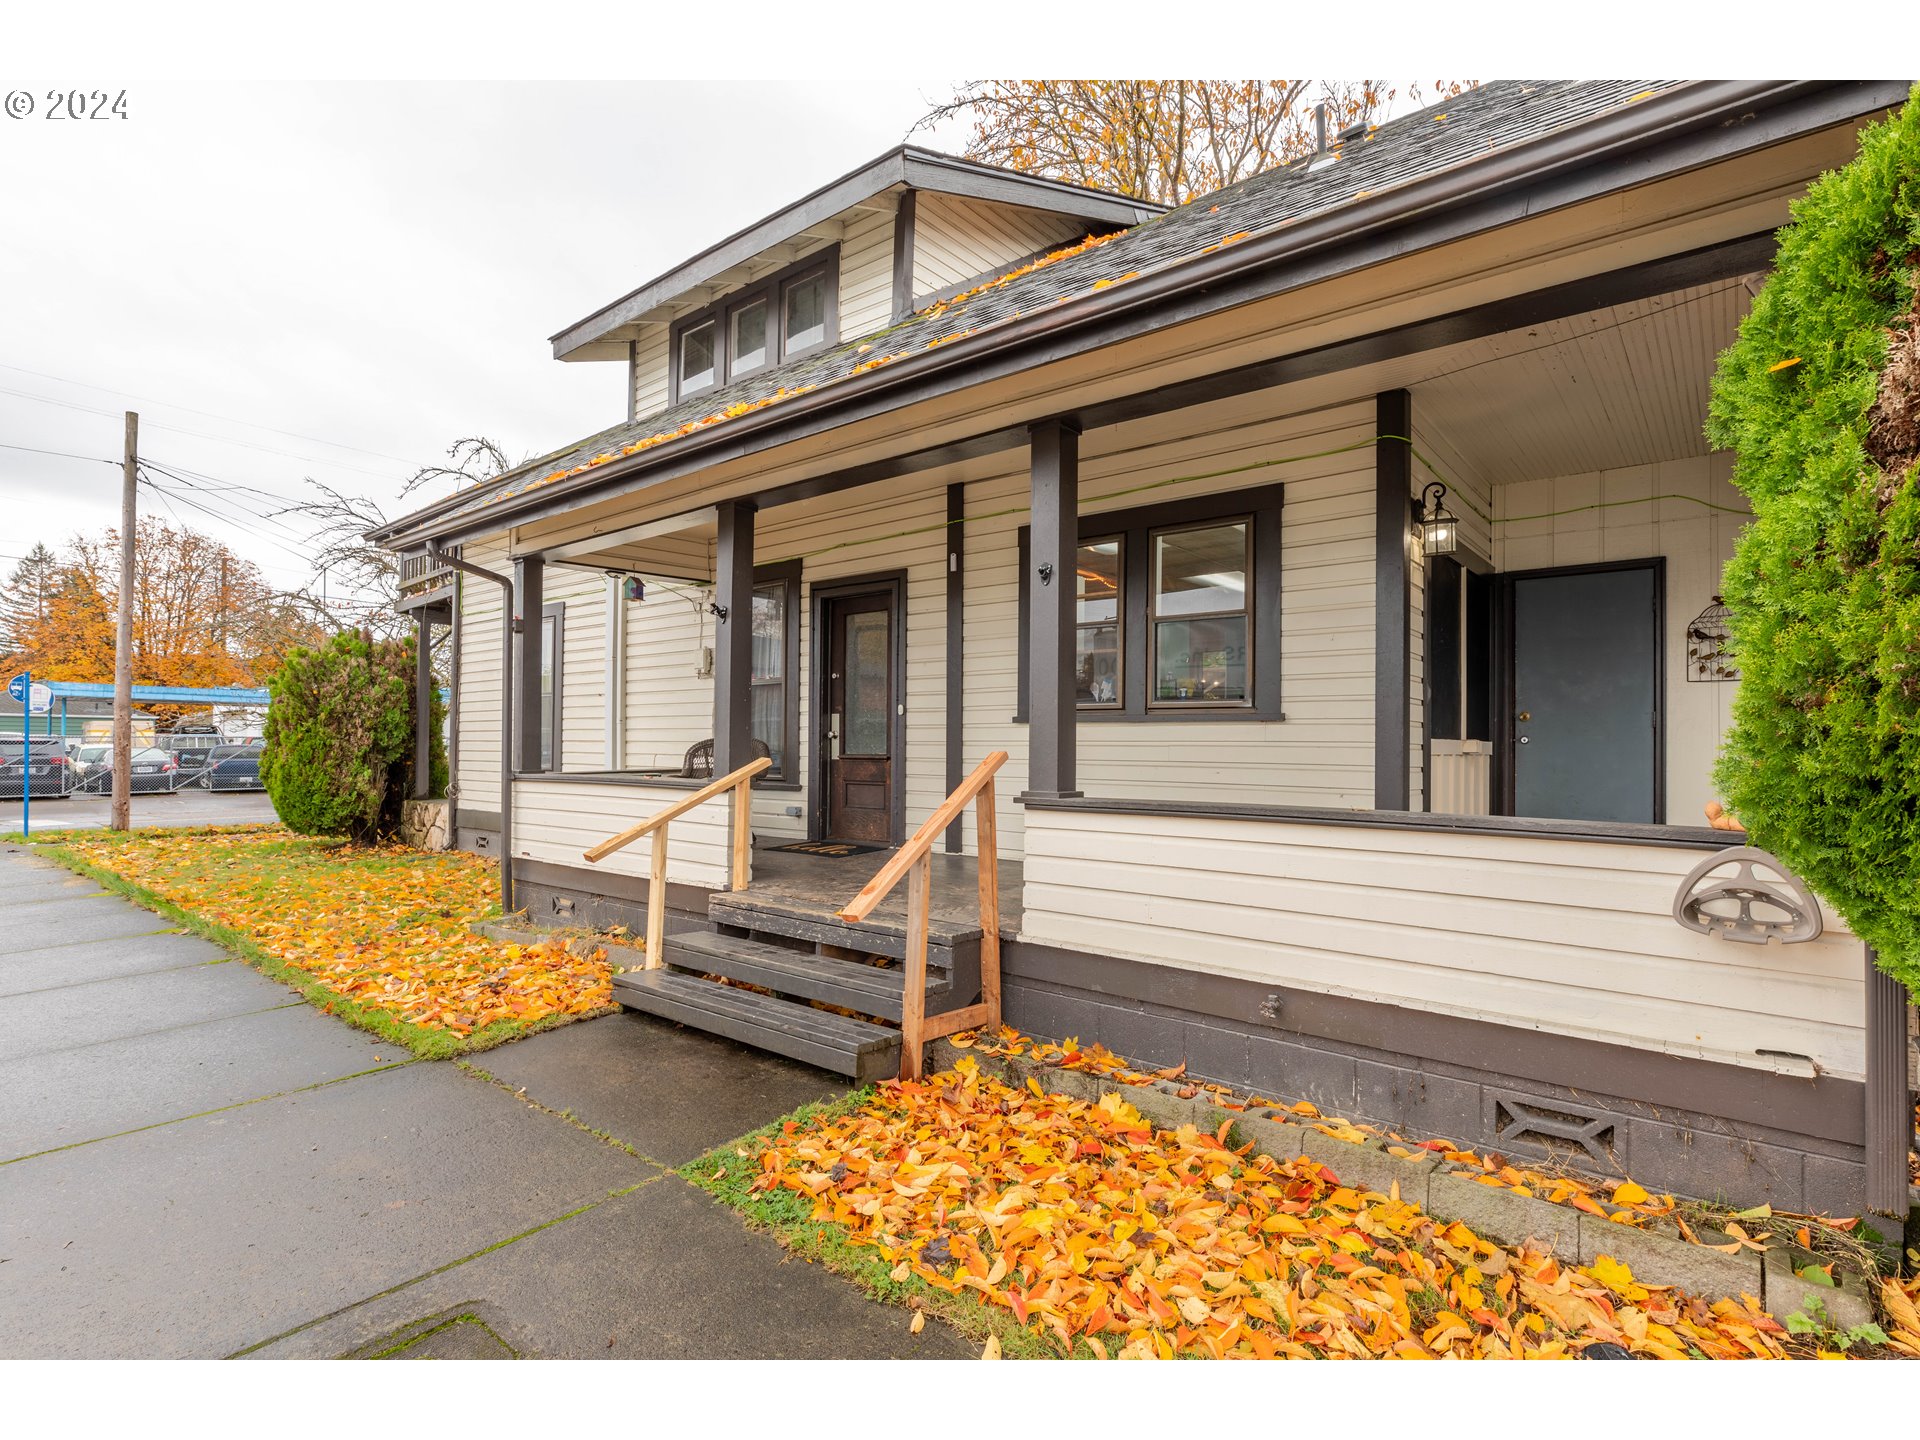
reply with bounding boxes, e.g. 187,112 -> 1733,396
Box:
369,81 -> 1907,545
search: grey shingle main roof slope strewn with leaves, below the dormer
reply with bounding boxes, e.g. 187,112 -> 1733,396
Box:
432,81 -> 1674,529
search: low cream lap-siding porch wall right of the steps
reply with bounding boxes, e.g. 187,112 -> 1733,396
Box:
1021,812 -> 1862,1077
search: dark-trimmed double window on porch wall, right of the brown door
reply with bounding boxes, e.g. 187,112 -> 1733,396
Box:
1014,486 -> 1284,722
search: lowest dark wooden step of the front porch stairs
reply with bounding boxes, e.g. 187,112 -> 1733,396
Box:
612,968 -> 900,1085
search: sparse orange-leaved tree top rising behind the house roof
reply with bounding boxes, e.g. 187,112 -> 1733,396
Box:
914,81 -> 1473,205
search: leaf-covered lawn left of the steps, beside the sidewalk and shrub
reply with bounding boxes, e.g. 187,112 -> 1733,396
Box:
33,828 -> 612,1056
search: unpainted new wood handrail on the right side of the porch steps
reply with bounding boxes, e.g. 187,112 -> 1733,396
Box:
839,751 -> 1006,1079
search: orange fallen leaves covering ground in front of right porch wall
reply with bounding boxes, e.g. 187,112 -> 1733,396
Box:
733,1058 -> 1786,1359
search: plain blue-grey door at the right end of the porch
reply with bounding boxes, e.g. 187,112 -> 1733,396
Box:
1507,564 -> 1665,824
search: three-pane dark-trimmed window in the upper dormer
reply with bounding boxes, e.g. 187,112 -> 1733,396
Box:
666,244 -> 839,405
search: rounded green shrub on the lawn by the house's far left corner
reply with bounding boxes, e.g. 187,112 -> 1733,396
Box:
259,630 -> 447,841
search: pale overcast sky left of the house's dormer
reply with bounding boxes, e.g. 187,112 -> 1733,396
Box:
0,81 -> 960,602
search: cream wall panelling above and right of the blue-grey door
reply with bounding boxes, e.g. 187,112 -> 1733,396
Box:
1494,453 -> 1747,826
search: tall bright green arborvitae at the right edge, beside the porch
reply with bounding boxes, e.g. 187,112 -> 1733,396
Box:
1707,88 -> 1920,995
